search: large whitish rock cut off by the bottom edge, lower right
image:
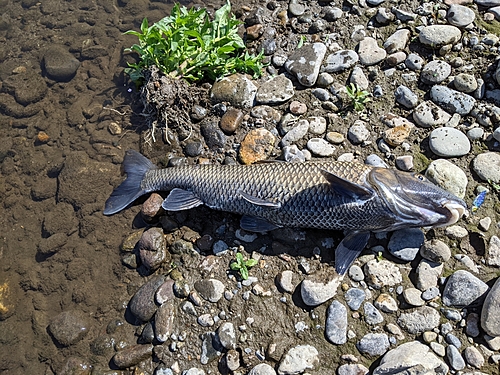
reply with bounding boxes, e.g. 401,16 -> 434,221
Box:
373,341 -> 448,375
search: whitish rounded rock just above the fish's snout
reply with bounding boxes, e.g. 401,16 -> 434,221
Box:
425,159 -> 468,198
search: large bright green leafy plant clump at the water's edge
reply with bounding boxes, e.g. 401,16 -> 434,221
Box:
125,0 -> 264,82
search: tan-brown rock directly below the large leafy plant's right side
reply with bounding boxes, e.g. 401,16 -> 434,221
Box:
210,74 -> 257,108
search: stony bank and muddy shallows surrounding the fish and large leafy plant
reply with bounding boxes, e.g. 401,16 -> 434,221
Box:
0,0 -> 500,375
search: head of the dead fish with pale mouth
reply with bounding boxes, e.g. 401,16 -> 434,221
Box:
368,168 -> 468,230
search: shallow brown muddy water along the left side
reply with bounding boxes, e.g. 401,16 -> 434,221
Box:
0,0 -> 238,374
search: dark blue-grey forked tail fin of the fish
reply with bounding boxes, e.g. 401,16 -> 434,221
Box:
104,150 -> 156,215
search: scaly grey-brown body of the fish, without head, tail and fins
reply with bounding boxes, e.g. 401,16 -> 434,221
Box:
141,162 -> 389,230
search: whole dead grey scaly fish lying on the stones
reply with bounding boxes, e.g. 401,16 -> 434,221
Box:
103,150 -> 468,275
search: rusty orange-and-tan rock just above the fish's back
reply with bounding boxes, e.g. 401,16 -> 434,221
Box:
238,128 -> 276,164
